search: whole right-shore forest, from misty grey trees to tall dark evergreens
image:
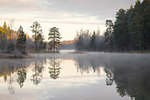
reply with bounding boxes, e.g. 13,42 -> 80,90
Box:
75,0 -> 150,52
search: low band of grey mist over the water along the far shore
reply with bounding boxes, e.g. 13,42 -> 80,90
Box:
0,52 -> 150,67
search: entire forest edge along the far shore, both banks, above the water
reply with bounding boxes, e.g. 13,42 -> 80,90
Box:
0,0 -> 150,55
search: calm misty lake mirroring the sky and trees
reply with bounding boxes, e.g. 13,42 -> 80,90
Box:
0,51 -> 150,100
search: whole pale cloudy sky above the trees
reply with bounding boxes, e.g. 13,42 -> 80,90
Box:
0,0 -> 136,40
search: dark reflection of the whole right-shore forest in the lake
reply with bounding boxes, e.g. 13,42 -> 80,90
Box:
76,55 -> 150,100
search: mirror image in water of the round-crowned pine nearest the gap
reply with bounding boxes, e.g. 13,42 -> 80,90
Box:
48,58 -> 61,79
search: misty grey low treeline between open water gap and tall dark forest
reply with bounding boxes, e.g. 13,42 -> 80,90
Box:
75,30 -> 104,51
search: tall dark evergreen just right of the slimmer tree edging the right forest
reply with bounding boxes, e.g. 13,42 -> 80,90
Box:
113,9 -> 129,51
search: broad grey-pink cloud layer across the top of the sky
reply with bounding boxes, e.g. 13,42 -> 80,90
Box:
0,0 -> 135,23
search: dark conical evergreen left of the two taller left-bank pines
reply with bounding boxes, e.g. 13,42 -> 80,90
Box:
16,26 -> 26,54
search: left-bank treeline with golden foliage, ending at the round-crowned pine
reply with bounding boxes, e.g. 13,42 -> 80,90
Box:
0,21 -> 61,54
